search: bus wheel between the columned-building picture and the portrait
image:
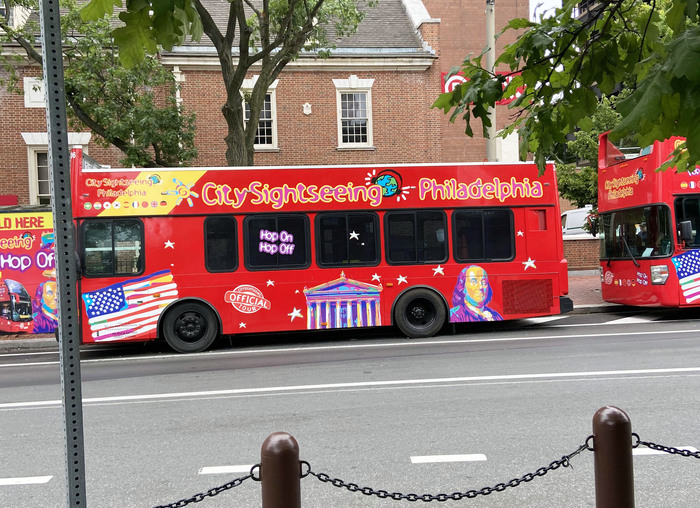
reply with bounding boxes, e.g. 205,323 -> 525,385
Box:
394,289 -> 446,339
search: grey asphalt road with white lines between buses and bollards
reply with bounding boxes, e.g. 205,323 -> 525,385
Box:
0,311 -> 700,508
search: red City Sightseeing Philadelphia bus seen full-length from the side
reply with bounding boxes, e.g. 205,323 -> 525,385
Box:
72,151 -> 572,352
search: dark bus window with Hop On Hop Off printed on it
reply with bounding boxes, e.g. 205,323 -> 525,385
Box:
243,215 -> 310,270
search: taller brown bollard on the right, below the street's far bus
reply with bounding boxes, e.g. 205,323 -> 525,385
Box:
593,406 -> 634,508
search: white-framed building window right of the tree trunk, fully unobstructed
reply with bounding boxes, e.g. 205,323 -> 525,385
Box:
333,74 -> 374,148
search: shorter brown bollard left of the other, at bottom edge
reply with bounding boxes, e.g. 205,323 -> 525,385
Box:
260,432 -> 301,508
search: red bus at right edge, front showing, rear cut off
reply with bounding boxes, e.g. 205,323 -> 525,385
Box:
598,133 -> 700,307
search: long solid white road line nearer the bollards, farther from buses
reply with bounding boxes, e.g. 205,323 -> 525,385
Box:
0,367 -> 700,409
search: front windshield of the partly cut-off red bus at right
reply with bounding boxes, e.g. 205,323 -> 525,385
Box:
600,205 -> 673,259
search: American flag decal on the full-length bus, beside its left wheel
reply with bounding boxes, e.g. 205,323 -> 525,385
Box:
83,270 -> 177,341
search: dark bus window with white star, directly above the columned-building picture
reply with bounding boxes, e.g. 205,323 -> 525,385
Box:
316,213 -> 379,267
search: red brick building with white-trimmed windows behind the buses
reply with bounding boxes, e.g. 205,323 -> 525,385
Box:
0,0 -> 528,204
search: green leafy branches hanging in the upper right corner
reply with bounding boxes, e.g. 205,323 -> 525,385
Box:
434,0 -> 700,175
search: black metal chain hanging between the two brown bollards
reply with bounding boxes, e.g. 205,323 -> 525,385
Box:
301,436 -> 593,503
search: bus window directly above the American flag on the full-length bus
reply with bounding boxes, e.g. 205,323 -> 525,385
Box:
82,220 -> 143,276
